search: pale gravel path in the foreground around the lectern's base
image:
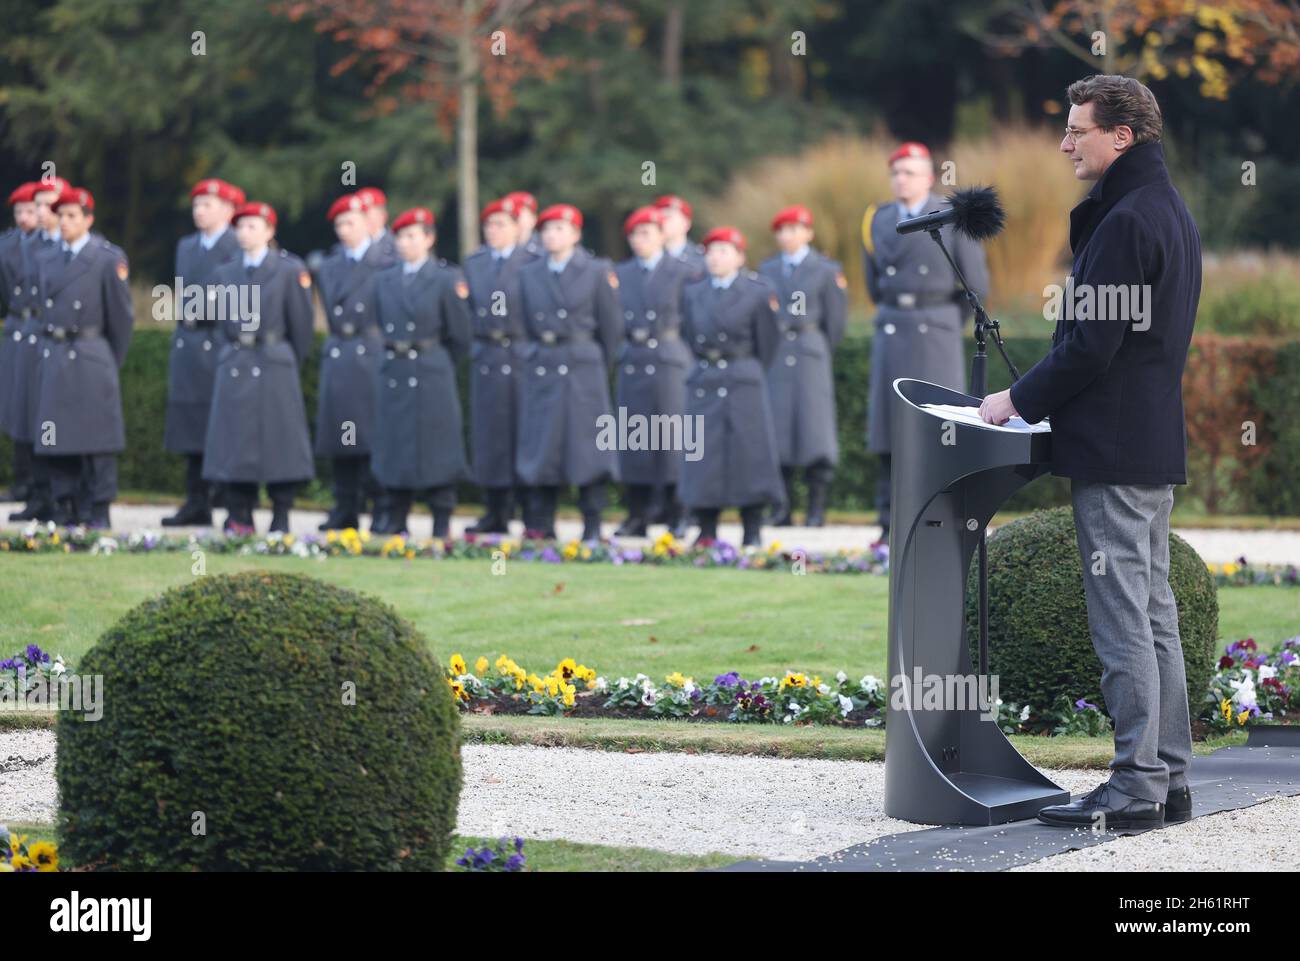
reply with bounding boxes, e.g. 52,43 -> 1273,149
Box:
10,731 -> 1300,871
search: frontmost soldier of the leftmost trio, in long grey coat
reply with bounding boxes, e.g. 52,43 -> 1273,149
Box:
33,187 -> 131,529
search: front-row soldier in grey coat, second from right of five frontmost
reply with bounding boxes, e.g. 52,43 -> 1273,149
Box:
516,204 -> 623,541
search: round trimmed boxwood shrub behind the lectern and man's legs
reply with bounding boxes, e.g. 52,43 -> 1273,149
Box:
966,507 -> 1218,717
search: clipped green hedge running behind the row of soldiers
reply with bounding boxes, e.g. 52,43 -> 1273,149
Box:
0,329 -> 1300,514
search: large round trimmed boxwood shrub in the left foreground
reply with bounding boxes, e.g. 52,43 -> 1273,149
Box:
56,571 -> 462,871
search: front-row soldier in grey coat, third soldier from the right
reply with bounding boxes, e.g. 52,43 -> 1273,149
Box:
681,226 -> 785,546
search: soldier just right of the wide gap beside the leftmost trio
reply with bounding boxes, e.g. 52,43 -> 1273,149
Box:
163,177 -> 244,527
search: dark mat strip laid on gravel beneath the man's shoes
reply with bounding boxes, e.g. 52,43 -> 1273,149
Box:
718,745 -> 1300,871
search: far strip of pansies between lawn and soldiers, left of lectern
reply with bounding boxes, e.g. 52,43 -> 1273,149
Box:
0,524 -> 889,573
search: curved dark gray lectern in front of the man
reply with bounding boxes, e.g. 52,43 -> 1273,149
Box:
885,377 -> 1070,824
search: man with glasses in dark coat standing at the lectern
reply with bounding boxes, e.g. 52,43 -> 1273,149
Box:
980,74 -> 1201,828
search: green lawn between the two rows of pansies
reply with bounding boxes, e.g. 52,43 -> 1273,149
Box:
0,554 -> 1300,678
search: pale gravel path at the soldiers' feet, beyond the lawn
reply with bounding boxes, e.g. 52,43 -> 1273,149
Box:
0,503 -> 1300,564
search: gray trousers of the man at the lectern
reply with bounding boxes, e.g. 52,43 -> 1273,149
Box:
1070,479 -> 1192,804
